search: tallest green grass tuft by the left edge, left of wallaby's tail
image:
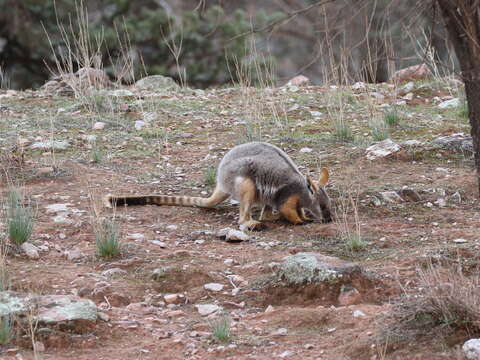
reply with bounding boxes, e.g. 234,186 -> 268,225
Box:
6,189 -> 35,245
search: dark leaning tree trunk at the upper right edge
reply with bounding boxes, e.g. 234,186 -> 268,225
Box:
436,0 -> 480,194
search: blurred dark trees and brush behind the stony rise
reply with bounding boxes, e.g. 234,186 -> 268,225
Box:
0,0 -> 455,89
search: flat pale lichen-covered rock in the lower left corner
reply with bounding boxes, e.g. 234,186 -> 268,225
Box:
0,291 -> 97,333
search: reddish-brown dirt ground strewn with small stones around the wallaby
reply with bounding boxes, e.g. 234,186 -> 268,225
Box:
0,81 -> 480,360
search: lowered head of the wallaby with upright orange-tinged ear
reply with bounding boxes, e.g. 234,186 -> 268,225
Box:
300,168 -> 332,222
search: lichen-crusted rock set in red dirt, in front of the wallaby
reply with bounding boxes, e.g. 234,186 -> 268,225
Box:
265,252 -> 378,306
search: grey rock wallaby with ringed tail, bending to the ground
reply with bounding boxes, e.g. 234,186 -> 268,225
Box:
104,142 -> 332,230
